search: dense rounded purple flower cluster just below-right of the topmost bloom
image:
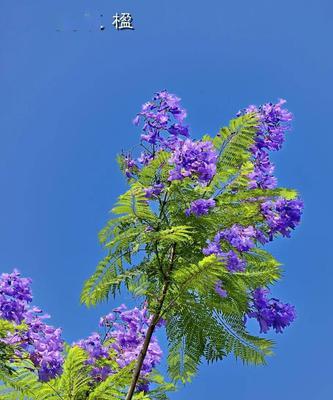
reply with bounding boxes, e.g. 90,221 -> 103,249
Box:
169,139 -> 217,184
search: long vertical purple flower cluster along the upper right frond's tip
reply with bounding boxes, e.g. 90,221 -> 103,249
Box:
239,100 -> 292,189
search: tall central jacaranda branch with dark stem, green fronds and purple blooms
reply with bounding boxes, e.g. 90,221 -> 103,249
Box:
82,91 -> 303,400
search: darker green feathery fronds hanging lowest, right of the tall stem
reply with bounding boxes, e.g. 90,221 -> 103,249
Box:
163,253 -> 279,381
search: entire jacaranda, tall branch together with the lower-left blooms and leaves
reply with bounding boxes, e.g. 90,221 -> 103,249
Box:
0,91 -> 303,400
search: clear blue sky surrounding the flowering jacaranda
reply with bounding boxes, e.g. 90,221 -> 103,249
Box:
0,0 -> 333,400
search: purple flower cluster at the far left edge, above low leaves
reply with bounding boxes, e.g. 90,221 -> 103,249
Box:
0,270 -> 63,381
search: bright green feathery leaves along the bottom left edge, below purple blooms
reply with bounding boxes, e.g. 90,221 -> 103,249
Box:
0,346 -> 175,400
